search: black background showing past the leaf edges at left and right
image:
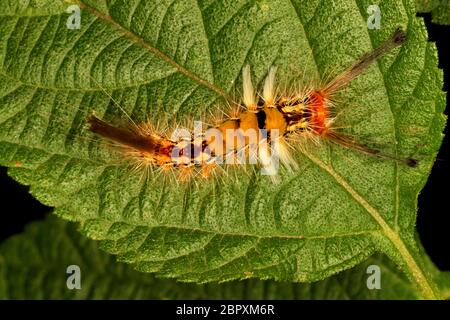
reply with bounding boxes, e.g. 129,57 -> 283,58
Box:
0,14 -> 450,270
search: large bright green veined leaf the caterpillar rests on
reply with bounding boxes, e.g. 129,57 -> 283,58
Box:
0,0 -> 445,298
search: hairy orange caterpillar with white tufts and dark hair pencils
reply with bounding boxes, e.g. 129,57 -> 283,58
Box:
87,28 -> 418,180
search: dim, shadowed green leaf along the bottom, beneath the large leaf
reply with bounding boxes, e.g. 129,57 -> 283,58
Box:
0,217 -> 426,299
